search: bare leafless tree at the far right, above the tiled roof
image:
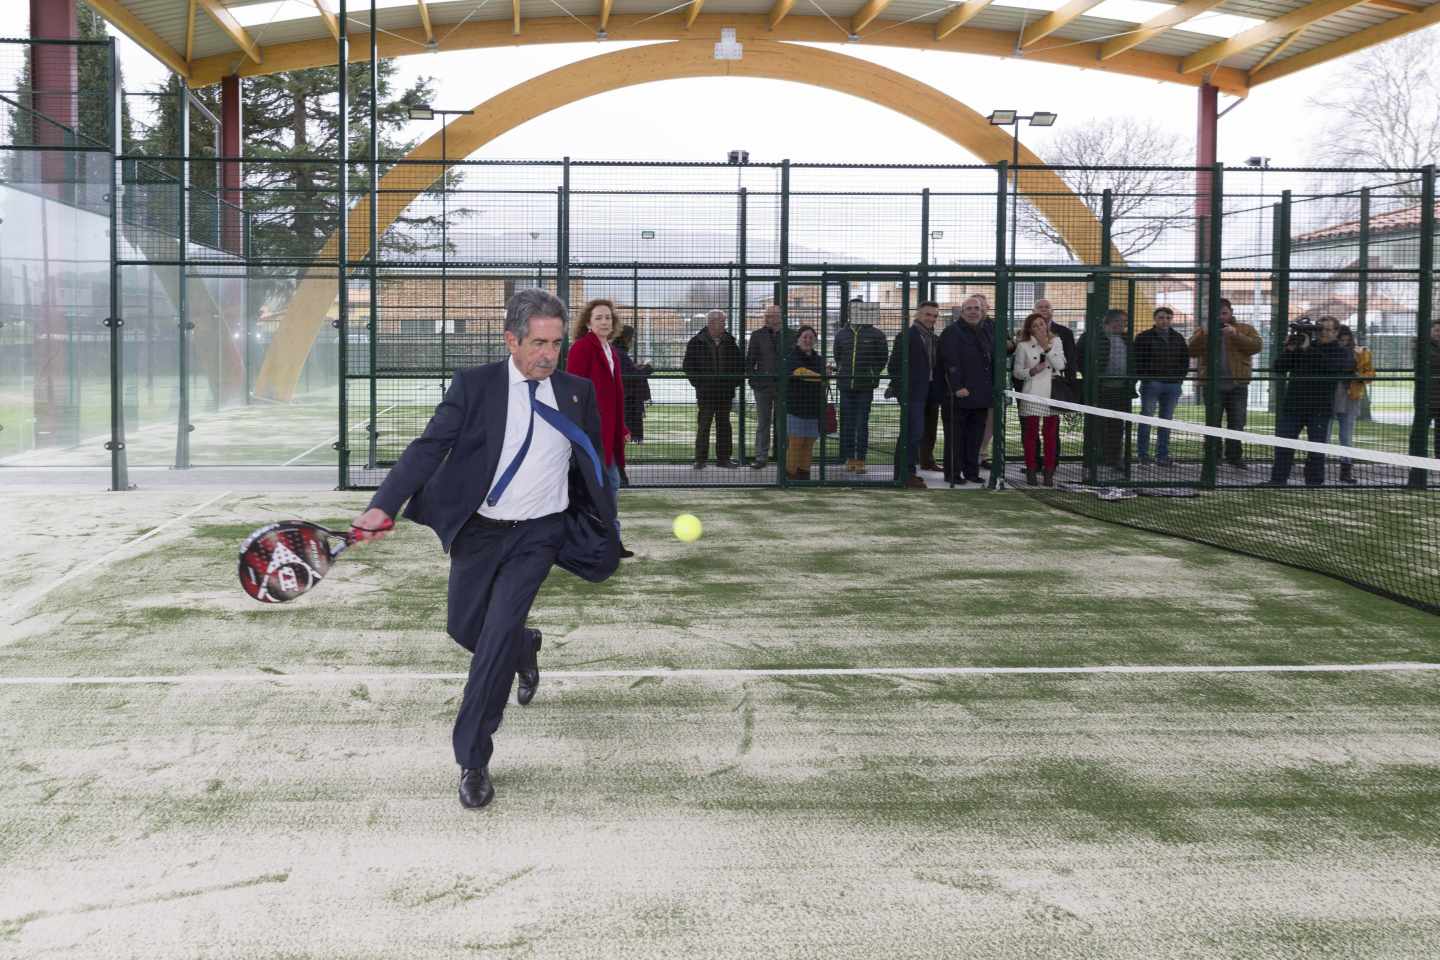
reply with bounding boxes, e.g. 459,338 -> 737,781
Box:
1310,29 -> 1440,178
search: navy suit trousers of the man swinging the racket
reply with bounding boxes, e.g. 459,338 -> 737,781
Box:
448,514 -> 564,769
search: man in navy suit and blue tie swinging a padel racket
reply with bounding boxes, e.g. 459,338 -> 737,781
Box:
354,289 -> 619,809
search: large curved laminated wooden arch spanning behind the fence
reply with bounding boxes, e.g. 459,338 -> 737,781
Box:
255,39 -> 1125,400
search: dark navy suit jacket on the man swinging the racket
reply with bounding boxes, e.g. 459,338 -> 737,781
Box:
370,360 -> 619,583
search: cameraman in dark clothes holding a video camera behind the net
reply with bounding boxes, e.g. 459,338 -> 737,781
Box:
1270,317 -> 1355,486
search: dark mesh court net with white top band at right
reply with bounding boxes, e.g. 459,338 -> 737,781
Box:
1004,391 -> 1440,613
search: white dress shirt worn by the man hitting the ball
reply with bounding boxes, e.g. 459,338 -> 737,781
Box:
480,357 -> 570,520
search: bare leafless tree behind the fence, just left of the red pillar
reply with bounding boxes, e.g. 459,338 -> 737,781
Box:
1020,115 -> 1195,259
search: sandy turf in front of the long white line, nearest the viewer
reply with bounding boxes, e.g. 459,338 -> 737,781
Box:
0,678 -> 1440,959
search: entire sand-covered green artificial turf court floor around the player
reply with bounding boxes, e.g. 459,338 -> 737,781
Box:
0,489 -> 1440,960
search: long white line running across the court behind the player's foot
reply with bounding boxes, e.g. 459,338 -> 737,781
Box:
0,662 -> 1440,687
